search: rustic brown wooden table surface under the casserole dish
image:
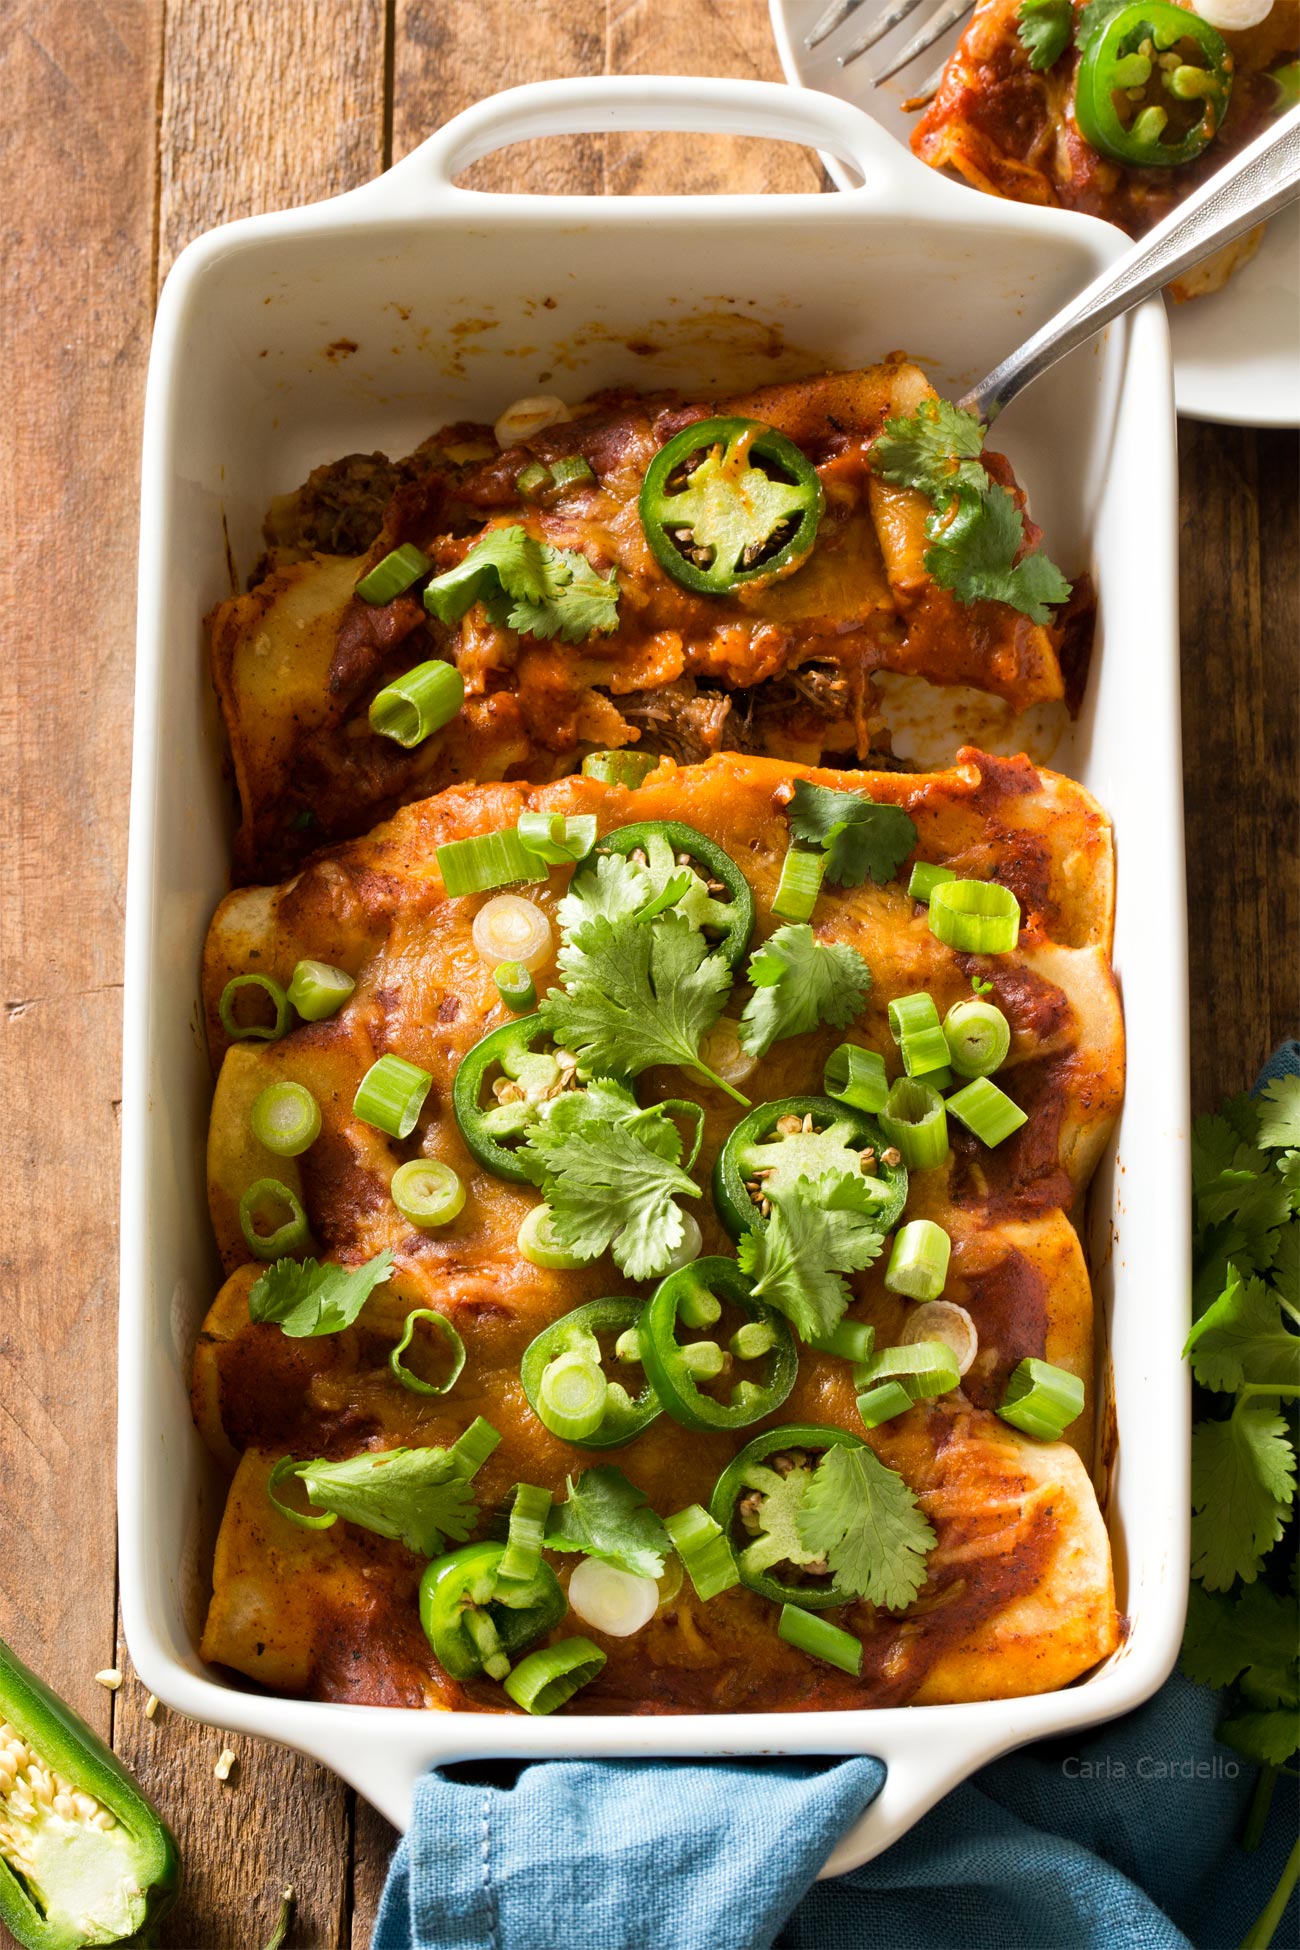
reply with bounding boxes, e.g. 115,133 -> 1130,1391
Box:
0,0 -> 1300,1950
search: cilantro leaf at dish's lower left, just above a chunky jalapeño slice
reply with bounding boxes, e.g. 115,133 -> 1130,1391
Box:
294,1449 -> 478,1558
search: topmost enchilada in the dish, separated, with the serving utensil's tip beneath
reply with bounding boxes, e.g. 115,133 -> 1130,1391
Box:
209,357 -> 1091,881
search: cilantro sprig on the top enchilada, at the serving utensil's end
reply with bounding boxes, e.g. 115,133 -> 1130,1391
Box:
871,400 -> 1070,624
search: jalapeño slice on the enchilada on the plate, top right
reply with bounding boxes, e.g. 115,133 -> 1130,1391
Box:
1074,0 -> 1232,170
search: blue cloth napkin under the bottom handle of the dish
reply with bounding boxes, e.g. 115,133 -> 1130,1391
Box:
372,1043 -> 1300,1950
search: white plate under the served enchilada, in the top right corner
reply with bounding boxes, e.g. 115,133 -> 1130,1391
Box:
770,0 -> 1300,427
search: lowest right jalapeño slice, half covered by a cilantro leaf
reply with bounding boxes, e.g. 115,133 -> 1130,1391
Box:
709,1422 -> 865,1611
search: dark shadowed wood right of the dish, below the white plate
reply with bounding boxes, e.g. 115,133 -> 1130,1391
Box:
1181,421 -> 1300,1110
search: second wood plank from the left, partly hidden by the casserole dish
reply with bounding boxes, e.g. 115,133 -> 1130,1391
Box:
104,0 -> 386,1950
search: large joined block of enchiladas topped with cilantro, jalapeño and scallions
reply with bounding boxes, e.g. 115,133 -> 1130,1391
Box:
193,744 -> 1123,1712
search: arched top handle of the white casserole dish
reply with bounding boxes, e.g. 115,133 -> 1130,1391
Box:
349,74 -> 912,215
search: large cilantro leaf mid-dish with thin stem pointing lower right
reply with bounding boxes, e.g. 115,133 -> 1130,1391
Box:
540,915 -> 745,1102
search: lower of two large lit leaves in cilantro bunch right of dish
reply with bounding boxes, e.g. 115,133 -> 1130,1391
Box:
1191,1402 -> 1296,1591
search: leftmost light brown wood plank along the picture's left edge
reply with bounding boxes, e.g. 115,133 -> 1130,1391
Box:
0,0 -> 160,1786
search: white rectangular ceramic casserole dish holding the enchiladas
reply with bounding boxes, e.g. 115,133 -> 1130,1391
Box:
119,78 -> 1189,1872
